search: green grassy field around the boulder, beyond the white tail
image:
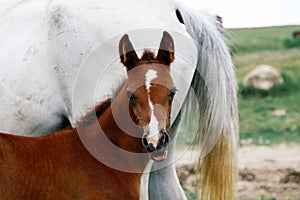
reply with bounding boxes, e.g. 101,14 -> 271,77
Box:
179,26 -> 300,145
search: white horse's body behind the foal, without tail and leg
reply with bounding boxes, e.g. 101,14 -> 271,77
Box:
0,0 -> 197,136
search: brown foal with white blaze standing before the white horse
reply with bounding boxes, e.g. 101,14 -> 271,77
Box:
0,32 -> 176,200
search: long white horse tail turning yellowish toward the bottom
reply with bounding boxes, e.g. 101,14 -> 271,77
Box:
177,5 -> 238,200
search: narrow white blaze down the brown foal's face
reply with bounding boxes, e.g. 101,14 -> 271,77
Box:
145,69 -> 159,147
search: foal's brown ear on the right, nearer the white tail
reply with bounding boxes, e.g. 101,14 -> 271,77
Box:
156,31 -> 174,66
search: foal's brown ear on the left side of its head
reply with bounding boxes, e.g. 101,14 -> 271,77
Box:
119,34 -> 139,71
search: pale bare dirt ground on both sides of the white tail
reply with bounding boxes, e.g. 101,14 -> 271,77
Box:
176,144 -> 300,200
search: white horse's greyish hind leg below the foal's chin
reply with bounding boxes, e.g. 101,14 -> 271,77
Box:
148,113 -> 186,200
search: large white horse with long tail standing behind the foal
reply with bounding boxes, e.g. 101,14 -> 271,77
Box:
0,0 -> 238,200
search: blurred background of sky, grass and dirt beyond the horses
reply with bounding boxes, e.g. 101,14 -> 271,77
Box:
177,0 -> 300,200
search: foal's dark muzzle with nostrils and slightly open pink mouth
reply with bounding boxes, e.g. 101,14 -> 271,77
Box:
142,130 -> 170,162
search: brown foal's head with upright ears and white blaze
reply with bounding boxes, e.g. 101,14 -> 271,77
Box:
119,32 -> 176,161
